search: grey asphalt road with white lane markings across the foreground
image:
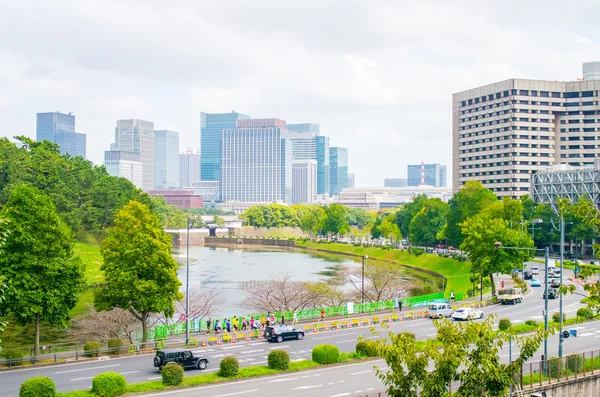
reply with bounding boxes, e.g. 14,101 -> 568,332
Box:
0,266 -> 600,397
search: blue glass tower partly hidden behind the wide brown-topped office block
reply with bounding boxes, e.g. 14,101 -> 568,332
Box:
200,112 -> 250,181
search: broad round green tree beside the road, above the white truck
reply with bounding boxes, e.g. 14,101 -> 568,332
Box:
460,214 -> 533,295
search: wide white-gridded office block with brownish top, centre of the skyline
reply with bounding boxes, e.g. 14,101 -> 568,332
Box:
221,119 -> 292,203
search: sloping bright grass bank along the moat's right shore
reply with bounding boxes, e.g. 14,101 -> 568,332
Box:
297,241 -> 471,298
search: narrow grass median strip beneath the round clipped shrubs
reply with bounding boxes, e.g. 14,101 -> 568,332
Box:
56,360 -> 321,397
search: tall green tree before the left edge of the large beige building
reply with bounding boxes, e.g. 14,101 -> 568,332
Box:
446,181 -> 498,247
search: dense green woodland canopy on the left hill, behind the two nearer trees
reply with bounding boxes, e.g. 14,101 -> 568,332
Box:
0,137 -> 182,233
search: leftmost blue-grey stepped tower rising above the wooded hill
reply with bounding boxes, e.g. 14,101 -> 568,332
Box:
35,112 -> 86,158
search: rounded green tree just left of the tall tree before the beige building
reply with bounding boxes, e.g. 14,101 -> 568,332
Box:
409,198 -> 448,245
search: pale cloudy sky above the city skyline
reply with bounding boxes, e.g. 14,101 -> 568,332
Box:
0,0 -> 600,186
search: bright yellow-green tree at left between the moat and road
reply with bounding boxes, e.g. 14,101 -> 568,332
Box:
94,201 -> 182,346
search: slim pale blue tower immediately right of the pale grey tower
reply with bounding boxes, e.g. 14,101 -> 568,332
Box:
154,130 -> 179,190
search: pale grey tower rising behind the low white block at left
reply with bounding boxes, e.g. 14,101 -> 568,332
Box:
111,119 -> 154,191
